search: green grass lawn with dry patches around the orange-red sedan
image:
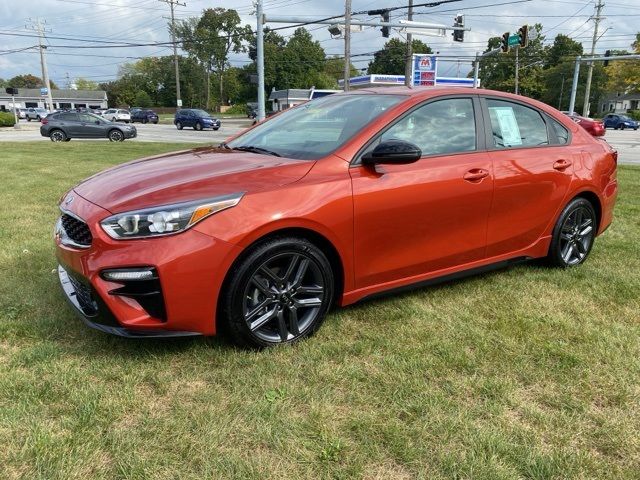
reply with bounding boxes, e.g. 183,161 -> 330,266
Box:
0,142 -> 640,480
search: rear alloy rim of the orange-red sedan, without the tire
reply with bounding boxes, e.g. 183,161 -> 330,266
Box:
560,207 -> 595,266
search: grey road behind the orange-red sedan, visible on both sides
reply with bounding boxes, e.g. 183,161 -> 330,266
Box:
0,119 -> 640,165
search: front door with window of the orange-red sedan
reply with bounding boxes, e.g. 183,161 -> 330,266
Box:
350,95 -> 493,288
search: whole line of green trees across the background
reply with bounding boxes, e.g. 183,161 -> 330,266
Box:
0,8 -> 640,112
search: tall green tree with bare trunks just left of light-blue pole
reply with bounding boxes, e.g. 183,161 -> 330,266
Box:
175,8 -> 251,107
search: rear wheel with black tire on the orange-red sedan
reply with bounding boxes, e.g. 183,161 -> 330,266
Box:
547,198 -> 597,268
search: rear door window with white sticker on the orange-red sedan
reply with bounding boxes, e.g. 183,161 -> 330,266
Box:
487,99 -> 549,148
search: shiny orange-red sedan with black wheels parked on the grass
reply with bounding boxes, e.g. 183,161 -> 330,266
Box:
55,88 -> 618,346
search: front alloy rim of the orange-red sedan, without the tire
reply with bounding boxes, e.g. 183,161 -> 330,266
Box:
243,252 -> 326,343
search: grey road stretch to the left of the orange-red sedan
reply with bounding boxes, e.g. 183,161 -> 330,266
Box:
0,119 -> 251,143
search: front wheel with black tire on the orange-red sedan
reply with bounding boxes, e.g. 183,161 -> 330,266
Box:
219,237 -> 335,348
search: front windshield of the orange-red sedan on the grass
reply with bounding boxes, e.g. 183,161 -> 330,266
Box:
227,94 -> 406,160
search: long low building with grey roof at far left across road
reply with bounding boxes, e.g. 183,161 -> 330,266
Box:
0,88 -> 108,110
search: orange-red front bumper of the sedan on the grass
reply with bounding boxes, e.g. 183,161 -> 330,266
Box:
55,191 -> 240,337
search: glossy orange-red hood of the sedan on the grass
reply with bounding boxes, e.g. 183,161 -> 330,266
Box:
74,147 -> 314,213
